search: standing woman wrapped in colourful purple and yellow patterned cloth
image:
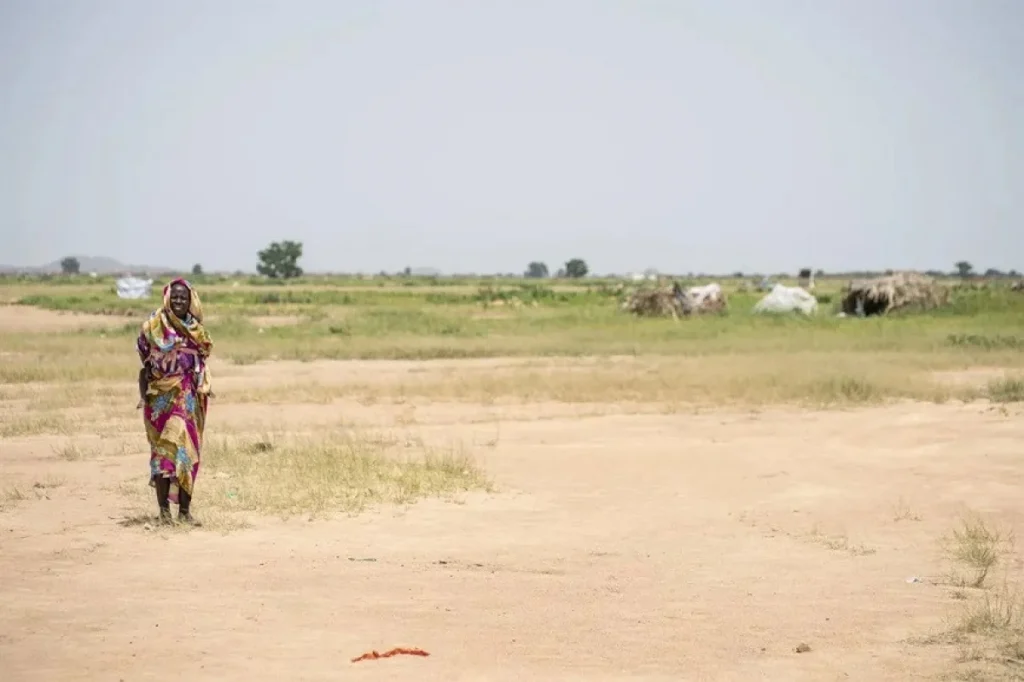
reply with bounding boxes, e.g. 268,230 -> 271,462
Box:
137,278 -> 213,525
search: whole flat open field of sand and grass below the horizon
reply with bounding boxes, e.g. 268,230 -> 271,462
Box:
0,278 -> 1024,681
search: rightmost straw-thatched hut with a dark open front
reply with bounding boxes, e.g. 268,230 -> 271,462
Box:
841,272 -> 949,317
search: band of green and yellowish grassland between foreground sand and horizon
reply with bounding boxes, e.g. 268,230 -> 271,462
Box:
0,278 -> 1024,404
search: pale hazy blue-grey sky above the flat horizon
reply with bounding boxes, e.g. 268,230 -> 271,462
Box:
0,0 -> 1024,272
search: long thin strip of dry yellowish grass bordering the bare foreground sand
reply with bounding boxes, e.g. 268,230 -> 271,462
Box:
218,353 -> 976,408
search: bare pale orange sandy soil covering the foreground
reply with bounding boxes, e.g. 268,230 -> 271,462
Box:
0,358 -> 1024,682
